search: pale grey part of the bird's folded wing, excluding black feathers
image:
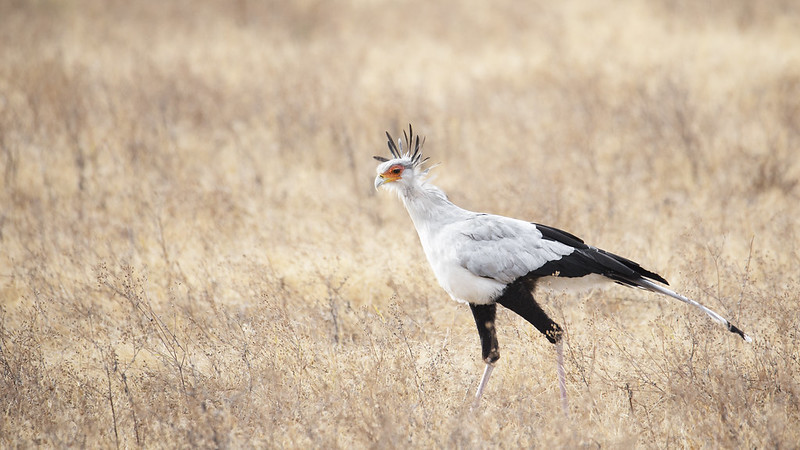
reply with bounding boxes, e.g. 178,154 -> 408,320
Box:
451,214 -> 575,284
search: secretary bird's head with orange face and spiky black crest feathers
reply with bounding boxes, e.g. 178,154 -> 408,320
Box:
373,124 -> 428,190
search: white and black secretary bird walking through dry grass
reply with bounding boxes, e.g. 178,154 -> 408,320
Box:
374,125 -> 752,413
